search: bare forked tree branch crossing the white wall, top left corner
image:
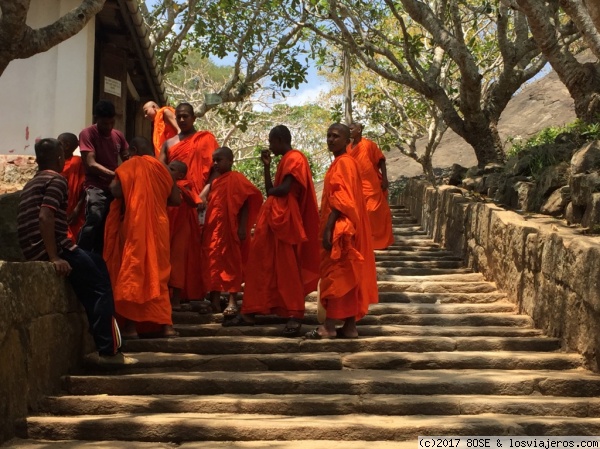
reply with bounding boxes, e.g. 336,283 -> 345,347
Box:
0,0 -> 106,76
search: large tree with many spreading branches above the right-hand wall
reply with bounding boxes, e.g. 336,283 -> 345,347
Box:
283,0 -> 577,165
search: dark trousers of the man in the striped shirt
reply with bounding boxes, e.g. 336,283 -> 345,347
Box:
60,248 -> 119,355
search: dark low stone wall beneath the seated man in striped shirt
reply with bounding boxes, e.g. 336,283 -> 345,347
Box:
0,261 -> 94,443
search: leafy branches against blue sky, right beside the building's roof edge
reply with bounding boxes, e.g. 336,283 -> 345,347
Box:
139,0 -> 308,121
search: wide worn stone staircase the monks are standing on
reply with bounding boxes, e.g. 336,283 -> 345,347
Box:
10,207 -> 600,449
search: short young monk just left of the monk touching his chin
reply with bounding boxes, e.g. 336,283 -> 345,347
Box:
200,147 -> 263,317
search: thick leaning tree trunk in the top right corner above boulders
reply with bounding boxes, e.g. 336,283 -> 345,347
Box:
505,0 -> 600,123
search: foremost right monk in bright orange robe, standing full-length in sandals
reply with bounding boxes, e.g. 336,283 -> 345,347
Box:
305,123 -> 378,340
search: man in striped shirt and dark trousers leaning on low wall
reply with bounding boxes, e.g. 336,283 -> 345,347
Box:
17,139 -> 137,366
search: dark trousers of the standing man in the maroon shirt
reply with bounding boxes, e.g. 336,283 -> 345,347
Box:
77,187 -> 113,255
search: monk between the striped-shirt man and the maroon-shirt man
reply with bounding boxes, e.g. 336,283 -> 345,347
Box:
58,133 -> 85,242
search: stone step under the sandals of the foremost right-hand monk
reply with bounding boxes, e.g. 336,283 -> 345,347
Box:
175,323 -> 543,338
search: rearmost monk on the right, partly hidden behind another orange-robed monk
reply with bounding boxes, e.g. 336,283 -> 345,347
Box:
347,123 -> 394,249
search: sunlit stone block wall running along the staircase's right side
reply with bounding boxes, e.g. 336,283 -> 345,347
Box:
400,180 -> 600,372
